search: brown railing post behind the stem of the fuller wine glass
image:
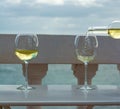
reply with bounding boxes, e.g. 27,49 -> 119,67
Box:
22,64 -> 48,109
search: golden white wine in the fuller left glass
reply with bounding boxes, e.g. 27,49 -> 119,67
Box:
15,49 -> 38,61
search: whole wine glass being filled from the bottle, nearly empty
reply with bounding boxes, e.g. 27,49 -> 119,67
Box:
74,32 -> 98,90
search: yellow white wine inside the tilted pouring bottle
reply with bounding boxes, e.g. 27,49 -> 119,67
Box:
108,28 -> 120,39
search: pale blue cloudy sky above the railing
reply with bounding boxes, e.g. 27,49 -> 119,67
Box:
0,0 -> 120,35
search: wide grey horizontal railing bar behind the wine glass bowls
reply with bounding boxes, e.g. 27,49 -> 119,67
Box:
0,34 -> 120,64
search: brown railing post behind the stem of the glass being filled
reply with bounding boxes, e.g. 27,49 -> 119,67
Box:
72,64 -> 98,109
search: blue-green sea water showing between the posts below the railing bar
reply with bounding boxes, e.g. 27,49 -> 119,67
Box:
0,64 -> 120,109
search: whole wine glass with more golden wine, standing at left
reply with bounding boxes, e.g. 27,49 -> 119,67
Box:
15,34 -> 39,90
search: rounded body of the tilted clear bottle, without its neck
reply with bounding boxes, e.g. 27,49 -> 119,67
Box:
108,20 -> 120,39
